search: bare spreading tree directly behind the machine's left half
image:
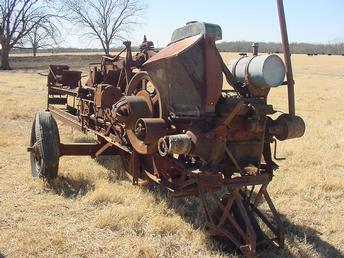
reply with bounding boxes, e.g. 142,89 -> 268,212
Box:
66,0 -> 144,55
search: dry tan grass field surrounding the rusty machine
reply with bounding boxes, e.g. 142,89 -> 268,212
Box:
0,54 -> 344,257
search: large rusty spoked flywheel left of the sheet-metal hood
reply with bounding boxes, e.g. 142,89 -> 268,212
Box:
126,72 -> 166,154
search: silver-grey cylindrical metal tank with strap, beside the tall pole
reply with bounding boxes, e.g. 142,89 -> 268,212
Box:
227,54 -> 285,88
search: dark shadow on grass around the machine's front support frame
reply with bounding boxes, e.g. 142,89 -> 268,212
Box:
143,183 -> 344,258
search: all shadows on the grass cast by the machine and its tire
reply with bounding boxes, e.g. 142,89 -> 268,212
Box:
39,156 -> 344,258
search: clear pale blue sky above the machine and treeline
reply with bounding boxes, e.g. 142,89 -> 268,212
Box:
63,0 -> 344,47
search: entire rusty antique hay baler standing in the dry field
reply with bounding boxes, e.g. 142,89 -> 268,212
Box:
28,0 -> 305,257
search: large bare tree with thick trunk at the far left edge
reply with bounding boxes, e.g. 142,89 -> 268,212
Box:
0,0 -> 58,70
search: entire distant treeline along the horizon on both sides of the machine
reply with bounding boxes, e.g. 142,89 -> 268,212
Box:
12,41 -> 344,55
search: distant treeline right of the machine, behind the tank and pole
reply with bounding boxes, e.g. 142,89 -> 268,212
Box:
217,41 -> 344,55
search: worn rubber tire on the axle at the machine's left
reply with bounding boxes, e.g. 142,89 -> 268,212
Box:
30,111 -> 60,181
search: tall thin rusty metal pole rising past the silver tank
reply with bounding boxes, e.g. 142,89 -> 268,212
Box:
276,0 -> 295,116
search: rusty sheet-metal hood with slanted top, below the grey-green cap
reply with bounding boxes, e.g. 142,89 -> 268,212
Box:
144,35 -> 223,116
